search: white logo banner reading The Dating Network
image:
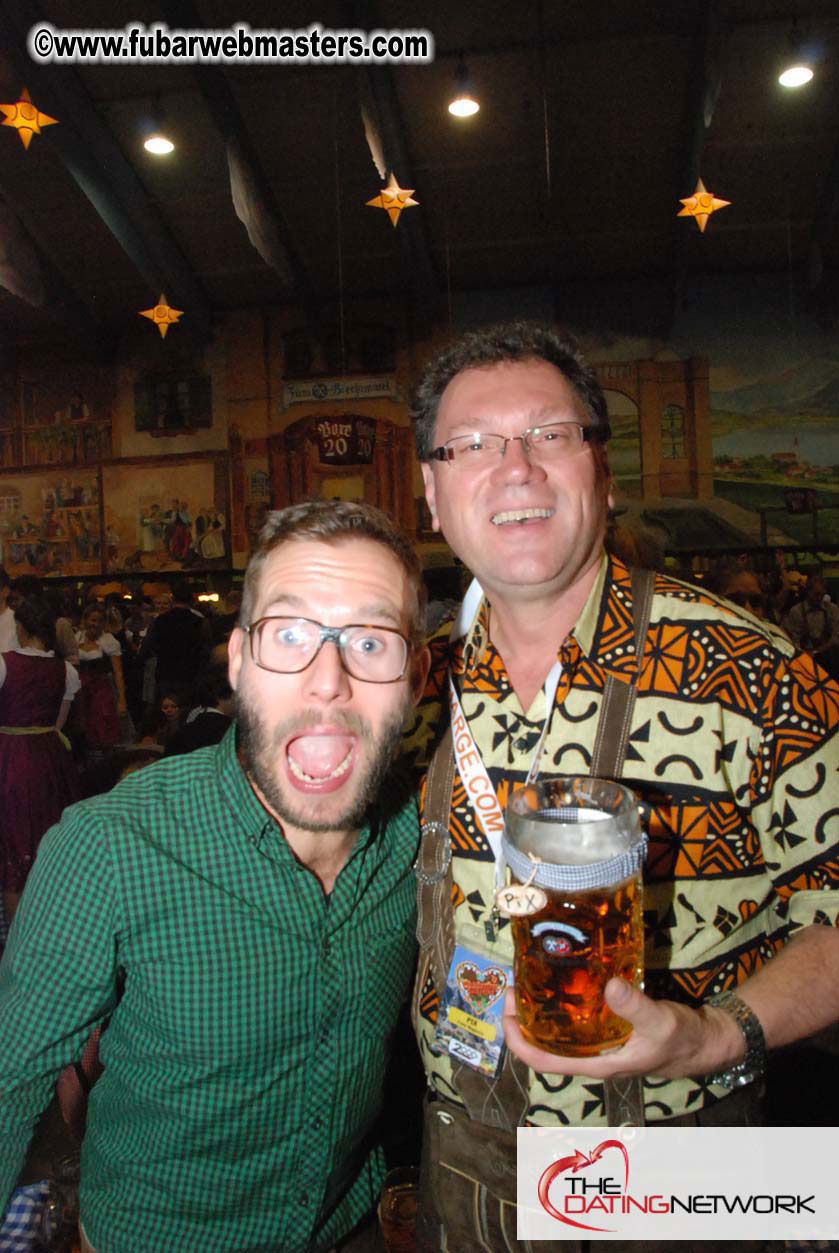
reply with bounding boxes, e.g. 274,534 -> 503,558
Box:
517,1126 -> 839,1243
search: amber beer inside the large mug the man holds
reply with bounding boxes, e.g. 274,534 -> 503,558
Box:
512,876 -> 644,1058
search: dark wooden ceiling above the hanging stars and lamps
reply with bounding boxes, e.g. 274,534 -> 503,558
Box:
0,0 -> 839,350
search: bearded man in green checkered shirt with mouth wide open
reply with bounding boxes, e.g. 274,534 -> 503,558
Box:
0,501 -> 428,1253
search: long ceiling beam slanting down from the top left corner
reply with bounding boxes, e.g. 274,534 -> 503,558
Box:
0,0 -> 212,341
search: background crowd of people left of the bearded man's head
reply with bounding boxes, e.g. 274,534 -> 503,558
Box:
0,566 -> 238,941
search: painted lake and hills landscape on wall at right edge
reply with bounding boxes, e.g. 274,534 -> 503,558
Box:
674,276 -> 839,548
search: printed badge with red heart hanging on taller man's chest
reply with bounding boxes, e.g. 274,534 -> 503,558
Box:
432,945 -> 512,1075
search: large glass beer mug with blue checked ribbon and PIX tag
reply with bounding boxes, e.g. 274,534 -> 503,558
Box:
496,777 -> 646,1058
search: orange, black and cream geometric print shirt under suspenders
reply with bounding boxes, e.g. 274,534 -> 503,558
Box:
409,554 -> 839,1125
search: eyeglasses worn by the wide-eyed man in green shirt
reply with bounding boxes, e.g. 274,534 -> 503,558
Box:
244,616 -> 412,683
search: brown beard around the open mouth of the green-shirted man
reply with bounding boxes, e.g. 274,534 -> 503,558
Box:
235,690 -> 413,833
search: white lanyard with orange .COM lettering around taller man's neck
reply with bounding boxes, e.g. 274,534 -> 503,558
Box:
448,579 -> 562,887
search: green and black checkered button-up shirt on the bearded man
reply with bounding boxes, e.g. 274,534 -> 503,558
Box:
0,729 -> 418,1253
